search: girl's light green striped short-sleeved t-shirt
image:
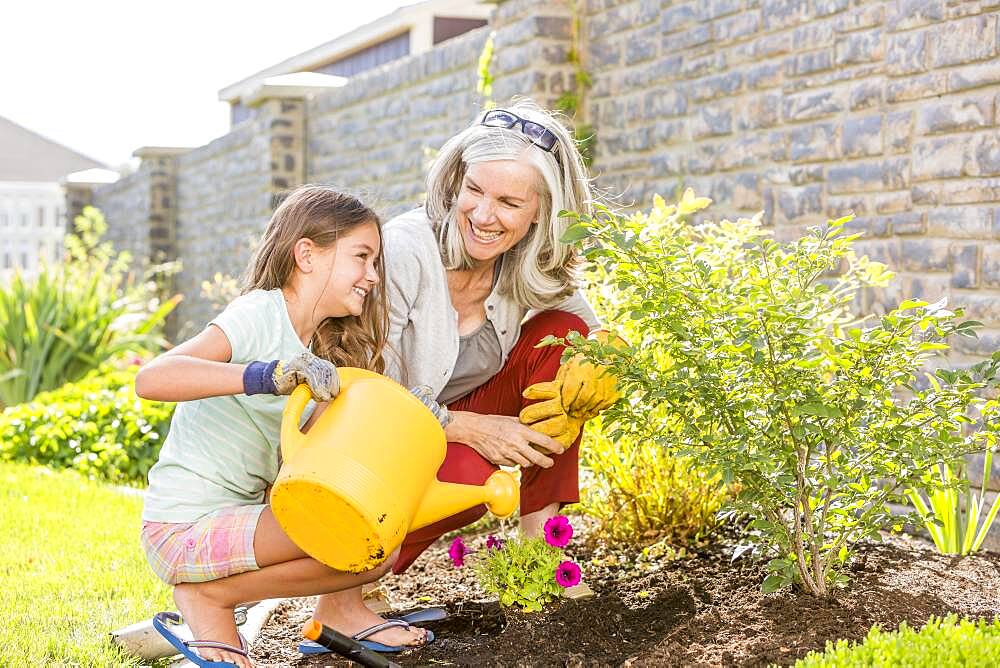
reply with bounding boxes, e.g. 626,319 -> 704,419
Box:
142,290 -> 313,523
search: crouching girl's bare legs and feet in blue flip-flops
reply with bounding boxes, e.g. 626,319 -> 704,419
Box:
174,508 -> 425,668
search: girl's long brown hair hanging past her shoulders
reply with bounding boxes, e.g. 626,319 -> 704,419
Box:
243,185 -> 389,373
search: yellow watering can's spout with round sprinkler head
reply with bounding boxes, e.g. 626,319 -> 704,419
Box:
410,471 -> 520,531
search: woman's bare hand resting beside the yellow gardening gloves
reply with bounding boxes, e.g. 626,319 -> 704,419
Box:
445,411 -> 566,468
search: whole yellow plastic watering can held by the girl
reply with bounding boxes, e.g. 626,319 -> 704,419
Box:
271,368 -> 520,573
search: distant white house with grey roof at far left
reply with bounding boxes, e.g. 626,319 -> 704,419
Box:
0,116 -> 110,282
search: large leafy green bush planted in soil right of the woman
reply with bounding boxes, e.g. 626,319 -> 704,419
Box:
564,190 -> 1000,595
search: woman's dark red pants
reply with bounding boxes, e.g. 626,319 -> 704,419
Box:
392,311 -> 589,573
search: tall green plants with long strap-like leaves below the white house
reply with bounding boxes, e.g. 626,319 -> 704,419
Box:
0,207 -> 180,406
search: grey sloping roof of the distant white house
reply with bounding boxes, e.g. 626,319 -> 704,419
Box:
0,116 -> 106,183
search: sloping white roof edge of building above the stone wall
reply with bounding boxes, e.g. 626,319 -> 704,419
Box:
219,0 -> 493,102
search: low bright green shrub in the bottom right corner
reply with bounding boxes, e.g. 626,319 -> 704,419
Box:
795,615 -> 1000,668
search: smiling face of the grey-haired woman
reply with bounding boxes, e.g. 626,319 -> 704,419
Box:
456,158 -> 540,262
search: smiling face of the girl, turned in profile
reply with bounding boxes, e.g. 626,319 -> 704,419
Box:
311,222 -> 382,318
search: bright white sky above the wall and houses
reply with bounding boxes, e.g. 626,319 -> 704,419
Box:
0,0 -> 416,167
